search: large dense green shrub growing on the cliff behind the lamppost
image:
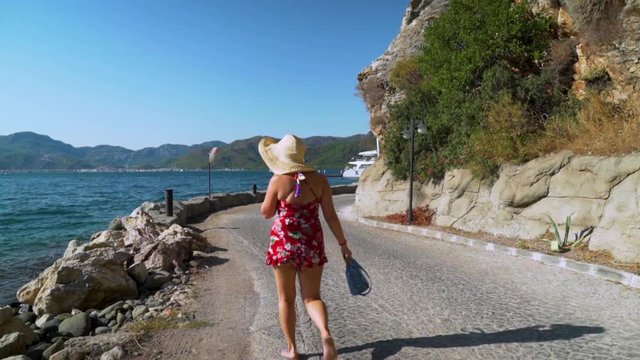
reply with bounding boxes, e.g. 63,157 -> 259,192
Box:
383,0 -> 567,178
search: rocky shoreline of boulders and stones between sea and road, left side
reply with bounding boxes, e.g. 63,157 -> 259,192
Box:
0,185 -> 357,360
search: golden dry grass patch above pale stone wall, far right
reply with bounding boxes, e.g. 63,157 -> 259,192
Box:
541,94 -> 640,155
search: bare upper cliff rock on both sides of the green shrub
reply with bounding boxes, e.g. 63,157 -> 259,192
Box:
358,0 -> 640,136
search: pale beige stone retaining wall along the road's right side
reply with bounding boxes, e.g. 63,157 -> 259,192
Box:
355,151 -> 640,262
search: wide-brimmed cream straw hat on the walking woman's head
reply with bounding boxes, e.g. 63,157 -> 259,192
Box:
258,134 -> 315,174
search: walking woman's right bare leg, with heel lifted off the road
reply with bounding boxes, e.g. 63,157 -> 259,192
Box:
298,266 -> 338,360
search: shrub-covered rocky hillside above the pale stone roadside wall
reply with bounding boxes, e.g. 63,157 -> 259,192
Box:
358,0 -> 640,179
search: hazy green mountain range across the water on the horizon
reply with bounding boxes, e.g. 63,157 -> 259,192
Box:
0,132 -> 375,170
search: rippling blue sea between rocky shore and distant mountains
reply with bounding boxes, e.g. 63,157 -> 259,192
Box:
0,170 -> 353,305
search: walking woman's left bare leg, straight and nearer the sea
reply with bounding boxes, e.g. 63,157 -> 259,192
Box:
274,264 -> 298,359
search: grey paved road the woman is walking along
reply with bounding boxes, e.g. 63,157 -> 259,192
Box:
190,195 -> 640,360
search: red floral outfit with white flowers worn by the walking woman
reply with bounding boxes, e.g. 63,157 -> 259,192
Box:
266,199 -> 327,271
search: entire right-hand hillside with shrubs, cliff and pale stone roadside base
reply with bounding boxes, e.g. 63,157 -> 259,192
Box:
354,0 -> 640,269
